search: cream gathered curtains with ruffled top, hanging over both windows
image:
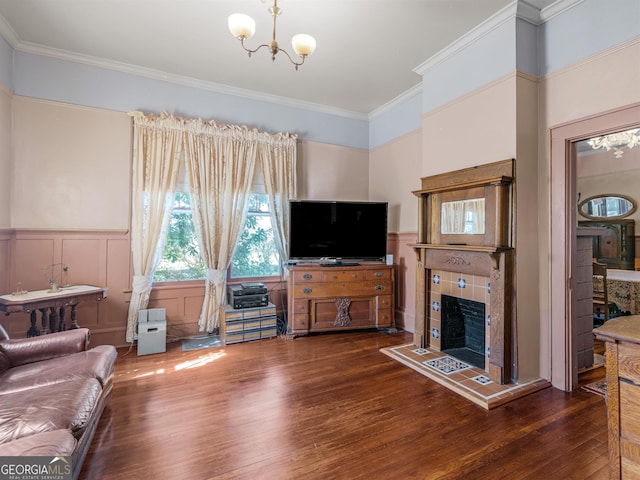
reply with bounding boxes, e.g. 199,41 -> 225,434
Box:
127,110 -> 296,342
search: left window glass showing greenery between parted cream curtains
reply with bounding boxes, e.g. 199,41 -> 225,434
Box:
153,193 -> 205,282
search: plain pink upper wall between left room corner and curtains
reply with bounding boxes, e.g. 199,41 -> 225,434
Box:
11,96 -> 131,230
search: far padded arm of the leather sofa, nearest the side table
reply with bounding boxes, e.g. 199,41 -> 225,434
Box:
0,328 -> 91,367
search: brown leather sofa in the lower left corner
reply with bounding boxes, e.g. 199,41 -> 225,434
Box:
0,328 -> 117,479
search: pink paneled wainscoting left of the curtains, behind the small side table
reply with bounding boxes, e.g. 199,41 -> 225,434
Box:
0,230 -> 131,346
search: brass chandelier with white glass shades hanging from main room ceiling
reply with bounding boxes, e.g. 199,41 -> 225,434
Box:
229,0 -> 316,70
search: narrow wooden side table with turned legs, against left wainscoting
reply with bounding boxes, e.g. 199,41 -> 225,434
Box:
0,285 -> 107,337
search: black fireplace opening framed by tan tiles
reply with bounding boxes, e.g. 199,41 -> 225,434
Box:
440,295 -> 486,369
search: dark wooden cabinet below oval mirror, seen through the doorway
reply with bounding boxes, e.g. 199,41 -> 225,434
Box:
578,220 -> 636,270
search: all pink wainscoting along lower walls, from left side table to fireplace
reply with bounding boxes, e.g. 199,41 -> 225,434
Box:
0,229 -> 416,346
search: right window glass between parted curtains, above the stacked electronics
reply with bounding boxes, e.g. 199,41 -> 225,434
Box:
231,193 -> 280,278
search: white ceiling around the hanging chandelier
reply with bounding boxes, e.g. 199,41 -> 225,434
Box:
0,0 -> 555,115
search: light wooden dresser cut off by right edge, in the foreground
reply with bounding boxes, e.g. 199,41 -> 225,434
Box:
594,315 -> 640,479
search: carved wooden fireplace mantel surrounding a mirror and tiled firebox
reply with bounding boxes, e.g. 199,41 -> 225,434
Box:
410,159 -> 517,384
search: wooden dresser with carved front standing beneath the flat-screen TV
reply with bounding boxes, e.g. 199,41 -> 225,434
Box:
287,263 -> 394,335
